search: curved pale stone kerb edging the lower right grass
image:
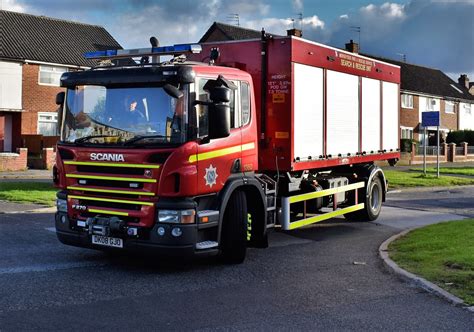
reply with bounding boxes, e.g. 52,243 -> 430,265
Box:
379,226 -> 468,312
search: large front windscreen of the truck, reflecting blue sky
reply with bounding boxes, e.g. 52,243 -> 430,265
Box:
61,85 -> 187,145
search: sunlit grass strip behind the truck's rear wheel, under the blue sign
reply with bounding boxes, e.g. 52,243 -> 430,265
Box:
384,170 -> 474,189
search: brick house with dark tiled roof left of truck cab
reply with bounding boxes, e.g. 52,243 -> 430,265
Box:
0,10 -> 121,169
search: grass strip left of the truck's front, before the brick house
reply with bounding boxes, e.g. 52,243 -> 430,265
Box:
0,182 -> 58,206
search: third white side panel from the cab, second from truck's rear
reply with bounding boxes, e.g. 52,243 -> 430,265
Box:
362,77 -> 381,153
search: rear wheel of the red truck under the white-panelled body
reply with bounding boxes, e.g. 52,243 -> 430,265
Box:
344,176 -> 383,221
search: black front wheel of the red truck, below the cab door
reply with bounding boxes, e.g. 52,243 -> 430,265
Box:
221,190 -> 248,264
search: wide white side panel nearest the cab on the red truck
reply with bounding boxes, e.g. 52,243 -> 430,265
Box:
293,63 -> 324,160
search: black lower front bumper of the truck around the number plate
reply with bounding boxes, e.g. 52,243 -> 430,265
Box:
55,212 -> 217,256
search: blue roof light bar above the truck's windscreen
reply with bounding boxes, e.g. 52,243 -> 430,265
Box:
84,44 -> 202,59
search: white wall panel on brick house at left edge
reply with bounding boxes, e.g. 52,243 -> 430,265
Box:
0,61 -> 22,110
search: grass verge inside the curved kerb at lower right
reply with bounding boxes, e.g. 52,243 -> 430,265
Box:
389,219 -> 474,305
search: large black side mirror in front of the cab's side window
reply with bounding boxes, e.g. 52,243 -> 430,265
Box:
209,86 -> 231,139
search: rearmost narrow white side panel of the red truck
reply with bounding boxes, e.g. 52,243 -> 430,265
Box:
382,82 -> 399,152
